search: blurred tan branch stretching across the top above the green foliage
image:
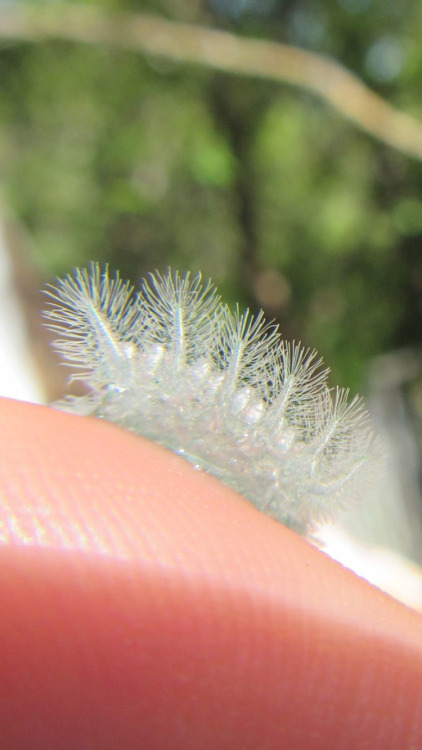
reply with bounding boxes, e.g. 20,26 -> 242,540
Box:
0,3 -> 422,160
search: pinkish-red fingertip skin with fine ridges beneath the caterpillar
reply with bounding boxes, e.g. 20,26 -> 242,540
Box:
0,400 -> 422,750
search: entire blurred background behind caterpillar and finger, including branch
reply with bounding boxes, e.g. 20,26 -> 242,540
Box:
0,0 -> 422,602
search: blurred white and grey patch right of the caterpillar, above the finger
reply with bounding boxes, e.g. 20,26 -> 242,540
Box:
330,349 -> 422,611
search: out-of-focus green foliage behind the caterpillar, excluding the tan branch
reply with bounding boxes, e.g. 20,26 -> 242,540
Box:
0,0 -> 422,389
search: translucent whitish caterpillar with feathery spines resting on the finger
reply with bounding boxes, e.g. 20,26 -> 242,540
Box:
46,264 -> 376,533
